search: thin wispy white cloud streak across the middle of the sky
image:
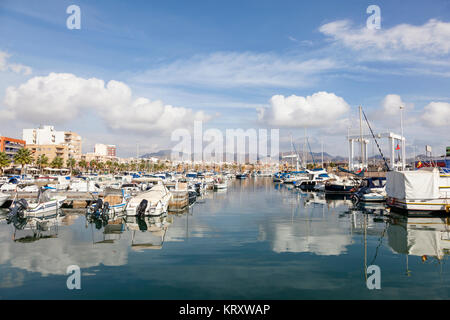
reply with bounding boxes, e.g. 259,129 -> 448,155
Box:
133,52 -> 336,88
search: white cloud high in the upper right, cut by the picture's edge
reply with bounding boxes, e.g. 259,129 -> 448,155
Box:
319,19 -> 450,56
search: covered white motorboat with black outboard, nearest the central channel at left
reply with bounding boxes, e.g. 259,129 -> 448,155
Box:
126,184 -> 172,217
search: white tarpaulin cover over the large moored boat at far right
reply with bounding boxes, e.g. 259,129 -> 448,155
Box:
386,168 -> 440,199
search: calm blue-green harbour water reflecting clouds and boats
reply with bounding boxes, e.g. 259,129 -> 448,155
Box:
0,178 -> 450,299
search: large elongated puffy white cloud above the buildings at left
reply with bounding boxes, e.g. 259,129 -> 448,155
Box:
4,73 -> 208,132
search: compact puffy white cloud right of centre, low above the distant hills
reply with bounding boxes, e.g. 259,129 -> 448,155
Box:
258,91 -> 350,127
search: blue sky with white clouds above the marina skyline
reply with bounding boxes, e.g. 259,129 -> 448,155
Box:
0,0 -> 450,157
